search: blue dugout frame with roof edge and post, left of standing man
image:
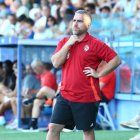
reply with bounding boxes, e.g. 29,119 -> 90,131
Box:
0,37 -> 60,127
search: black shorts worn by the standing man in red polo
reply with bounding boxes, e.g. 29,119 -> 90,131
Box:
50,95 -> 99,131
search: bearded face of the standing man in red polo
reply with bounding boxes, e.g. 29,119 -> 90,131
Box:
72,13 -> 88,35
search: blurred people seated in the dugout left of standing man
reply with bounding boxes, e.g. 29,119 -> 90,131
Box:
0,60 -> 57,130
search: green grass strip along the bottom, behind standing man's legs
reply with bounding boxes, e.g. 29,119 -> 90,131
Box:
0,127 -> 138,140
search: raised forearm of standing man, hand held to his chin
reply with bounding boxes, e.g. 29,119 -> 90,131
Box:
51,35 -> 78,68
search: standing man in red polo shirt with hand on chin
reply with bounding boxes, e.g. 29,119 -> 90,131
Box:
46,10 -> 121,140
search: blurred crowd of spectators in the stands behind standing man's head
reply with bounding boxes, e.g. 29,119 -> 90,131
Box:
0,0 -> 140,40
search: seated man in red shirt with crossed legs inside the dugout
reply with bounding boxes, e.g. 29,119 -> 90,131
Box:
24,60 -> 57,130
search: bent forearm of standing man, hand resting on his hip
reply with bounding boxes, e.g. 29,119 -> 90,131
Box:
83,56 -> 121,78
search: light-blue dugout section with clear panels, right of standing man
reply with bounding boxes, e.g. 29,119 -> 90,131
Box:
112,39 -> 140,129
